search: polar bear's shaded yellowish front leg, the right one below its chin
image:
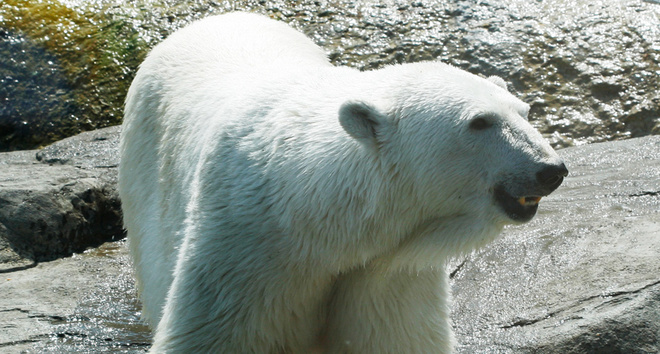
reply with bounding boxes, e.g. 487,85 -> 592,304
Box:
324,265 -> 454,353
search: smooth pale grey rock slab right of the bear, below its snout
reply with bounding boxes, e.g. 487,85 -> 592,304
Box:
453,137 -> 660,353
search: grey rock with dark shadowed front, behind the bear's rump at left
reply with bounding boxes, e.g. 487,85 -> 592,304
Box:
0,127 -> 123,268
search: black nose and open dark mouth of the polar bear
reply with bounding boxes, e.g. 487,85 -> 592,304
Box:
494,160 -> 568,222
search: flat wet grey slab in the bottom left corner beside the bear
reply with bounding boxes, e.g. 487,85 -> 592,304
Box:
0,241 -> 150,354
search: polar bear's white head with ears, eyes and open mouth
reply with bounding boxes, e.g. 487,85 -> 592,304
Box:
339,63 -> 568,230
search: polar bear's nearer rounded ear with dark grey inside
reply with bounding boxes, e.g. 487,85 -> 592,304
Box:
339,101 -> 385,146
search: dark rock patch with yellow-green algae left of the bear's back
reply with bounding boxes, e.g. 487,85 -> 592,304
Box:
0,0 -> 147,151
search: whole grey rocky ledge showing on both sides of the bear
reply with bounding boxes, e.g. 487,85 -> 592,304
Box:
0,127 -> 660,353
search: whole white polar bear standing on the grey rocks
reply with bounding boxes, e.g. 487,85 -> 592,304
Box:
119,13 -> 567,353
